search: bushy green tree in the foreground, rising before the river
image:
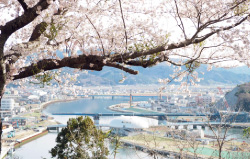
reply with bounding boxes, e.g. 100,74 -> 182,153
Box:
50,116 -> 108,159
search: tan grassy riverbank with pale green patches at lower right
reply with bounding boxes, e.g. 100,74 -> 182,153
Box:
121,129 -> 250,159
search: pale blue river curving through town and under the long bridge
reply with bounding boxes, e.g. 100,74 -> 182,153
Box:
10,97 -> 160,159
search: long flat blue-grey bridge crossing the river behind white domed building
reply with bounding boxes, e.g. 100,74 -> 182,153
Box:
52,113 -> 206,120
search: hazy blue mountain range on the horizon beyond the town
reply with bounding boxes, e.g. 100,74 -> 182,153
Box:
66,63 -> 250,86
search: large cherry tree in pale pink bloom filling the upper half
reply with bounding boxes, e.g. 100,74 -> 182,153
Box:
0,0 -> 250,154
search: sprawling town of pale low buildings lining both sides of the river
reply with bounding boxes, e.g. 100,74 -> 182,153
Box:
1,85 -> 249,158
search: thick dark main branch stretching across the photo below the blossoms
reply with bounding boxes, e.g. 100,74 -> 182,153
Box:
8,11 -> 248,80
